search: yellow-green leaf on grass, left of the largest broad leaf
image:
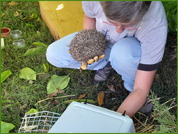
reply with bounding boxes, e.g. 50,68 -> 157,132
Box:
19,67 -> 36,80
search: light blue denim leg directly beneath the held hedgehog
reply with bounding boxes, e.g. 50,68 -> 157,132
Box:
46,32 -> 111,70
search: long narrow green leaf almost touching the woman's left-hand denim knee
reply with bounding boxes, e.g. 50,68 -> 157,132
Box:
23,47 -> 46,56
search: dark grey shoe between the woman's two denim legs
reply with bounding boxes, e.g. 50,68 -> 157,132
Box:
93,62 -> 113,84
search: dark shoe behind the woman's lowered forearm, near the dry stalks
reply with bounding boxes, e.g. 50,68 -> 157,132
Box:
138,98 -> 153,116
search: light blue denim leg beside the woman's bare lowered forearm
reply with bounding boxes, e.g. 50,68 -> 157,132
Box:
109,37 -> 141,92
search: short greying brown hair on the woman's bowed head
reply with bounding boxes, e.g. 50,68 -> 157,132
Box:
100,1 -> 151,23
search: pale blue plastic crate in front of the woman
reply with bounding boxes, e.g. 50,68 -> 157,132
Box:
48,102 -> 135,133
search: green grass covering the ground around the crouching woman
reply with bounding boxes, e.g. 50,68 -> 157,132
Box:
1,1 -> 177,133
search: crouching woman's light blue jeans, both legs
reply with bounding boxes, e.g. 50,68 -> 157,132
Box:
46,32 -> 141,92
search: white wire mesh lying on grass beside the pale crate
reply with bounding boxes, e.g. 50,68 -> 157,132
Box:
18,111 -> 60,133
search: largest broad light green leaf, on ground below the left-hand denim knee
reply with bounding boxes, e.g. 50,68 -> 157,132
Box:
47,75 -> 70,94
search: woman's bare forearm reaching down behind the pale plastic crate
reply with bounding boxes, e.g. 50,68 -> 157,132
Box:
117,70 -> 156,117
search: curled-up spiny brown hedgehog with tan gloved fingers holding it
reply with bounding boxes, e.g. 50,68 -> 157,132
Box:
68,29 -> 107,70
